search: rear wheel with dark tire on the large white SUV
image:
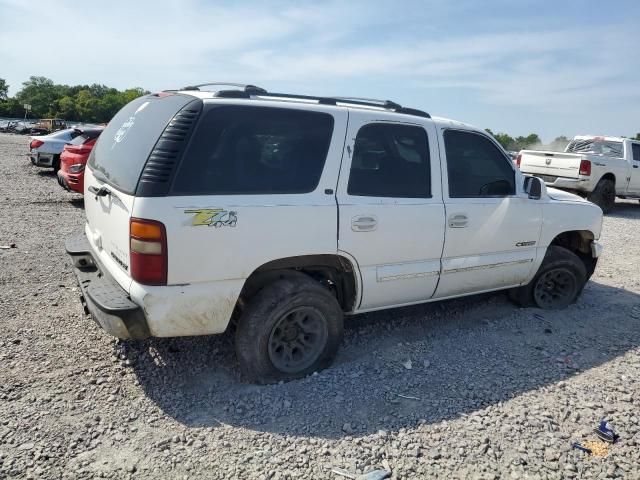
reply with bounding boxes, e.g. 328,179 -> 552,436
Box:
236,274 -> 343,383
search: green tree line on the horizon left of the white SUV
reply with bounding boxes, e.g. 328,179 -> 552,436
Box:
0,76 -> 149,123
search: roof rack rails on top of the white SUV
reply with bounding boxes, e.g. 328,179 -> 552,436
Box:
165,82 -> 431,118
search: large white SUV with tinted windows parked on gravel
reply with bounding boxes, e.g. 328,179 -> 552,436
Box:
66,84 -> 602,382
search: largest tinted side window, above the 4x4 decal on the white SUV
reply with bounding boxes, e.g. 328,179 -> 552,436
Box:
172,106 -> 333,195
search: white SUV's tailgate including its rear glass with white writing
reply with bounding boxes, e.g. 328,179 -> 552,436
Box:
84,95 -> 194,291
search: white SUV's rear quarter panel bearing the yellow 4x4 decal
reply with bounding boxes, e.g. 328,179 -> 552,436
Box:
130,110 -> 347,336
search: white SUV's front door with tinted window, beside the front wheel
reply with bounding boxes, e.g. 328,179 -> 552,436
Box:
436,129 -> 542,298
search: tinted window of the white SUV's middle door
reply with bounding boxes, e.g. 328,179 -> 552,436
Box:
347,123 -> 431,198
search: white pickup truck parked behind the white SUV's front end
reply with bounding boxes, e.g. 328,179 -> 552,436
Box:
516,135 -> 640,213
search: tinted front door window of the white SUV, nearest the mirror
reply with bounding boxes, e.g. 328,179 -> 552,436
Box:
444,130 -> 516,198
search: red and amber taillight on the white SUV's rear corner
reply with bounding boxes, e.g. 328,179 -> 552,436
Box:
129,218 -> 167,285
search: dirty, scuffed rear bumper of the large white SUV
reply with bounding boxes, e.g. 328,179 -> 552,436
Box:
65,234 -> 150,340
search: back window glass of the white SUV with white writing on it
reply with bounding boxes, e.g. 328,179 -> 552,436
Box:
89,95 -> 193,194
